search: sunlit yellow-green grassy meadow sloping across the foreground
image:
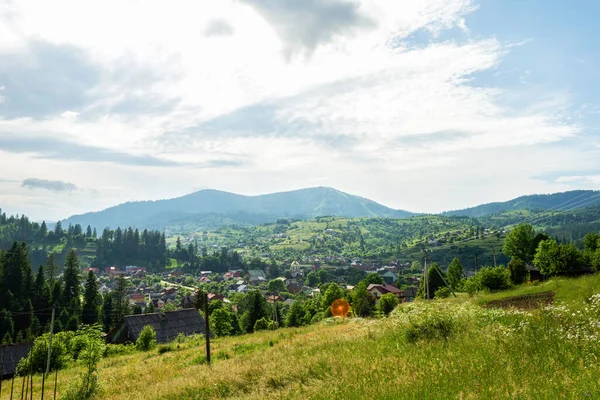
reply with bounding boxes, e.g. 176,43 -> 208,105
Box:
1,275 -> 600,399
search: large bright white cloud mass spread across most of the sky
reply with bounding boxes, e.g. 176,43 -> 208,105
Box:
0,0 -> 585,217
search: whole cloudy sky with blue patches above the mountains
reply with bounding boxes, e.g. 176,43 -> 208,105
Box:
0,0 -> 600,221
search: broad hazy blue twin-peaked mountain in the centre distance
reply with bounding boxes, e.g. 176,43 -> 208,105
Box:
64,187 -> 412,229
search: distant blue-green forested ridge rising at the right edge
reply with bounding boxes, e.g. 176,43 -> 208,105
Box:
442,190 -> 600,217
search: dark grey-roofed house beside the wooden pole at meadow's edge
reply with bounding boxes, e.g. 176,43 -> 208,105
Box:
111,308 -> 212,343
